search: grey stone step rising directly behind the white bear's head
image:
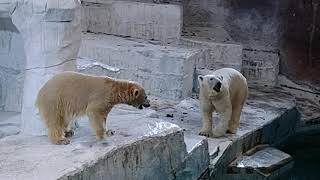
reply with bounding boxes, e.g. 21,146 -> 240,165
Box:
181,27 -> 242,71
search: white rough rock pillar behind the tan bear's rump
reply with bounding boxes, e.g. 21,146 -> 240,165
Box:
12,0 -> 81,135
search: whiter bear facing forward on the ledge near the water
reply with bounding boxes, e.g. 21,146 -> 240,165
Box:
198,68 -> 248,137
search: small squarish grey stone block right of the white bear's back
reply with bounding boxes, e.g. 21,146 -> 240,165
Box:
242,49 -> 279,86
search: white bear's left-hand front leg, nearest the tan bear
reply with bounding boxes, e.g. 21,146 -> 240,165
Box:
199,100 -> 214,137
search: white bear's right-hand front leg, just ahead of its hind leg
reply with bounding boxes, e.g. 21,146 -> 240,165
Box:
213,102 -> 232,137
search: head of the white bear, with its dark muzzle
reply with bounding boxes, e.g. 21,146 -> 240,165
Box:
198,75 -> 223,97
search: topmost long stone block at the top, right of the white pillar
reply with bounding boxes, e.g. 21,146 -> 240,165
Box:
82,0 -> 182,44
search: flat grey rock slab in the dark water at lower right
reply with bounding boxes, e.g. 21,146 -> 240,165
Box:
227,146 -> 294,179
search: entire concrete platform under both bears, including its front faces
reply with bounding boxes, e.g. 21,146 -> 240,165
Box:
0,89 -> 298,180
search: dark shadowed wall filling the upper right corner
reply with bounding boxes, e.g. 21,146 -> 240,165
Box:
184,0 -> 320,85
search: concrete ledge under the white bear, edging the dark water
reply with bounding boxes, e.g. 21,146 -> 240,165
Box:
154,88 -> 299,178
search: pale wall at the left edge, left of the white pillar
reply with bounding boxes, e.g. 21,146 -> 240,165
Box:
0,17 -> 26,112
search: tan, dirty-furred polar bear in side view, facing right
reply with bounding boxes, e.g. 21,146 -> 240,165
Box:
36,72 -> 150,144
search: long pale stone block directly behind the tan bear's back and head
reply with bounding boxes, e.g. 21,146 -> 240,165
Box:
78,33 -> 203,100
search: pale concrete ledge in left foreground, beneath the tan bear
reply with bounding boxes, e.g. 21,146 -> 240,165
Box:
0,106 -> 187,180
